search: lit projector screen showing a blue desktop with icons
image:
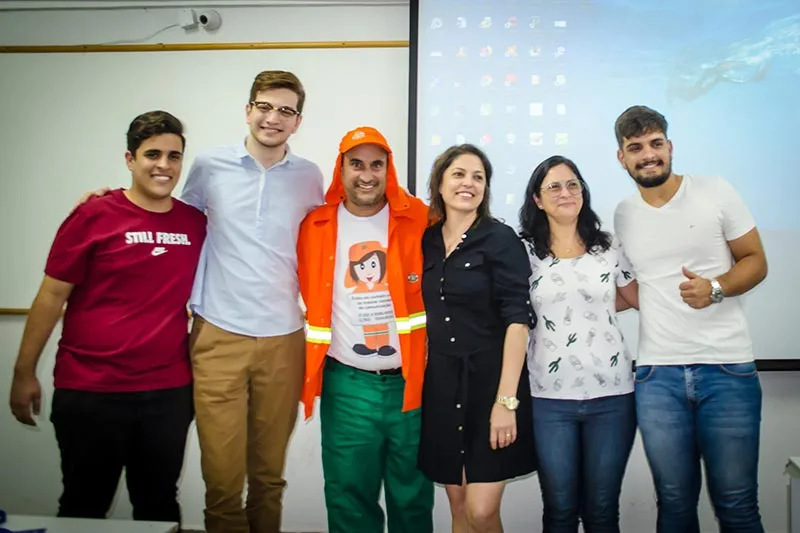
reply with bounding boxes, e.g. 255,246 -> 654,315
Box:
409,0 -> 800,370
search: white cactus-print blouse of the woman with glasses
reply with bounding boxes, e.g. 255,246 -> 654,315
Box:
525,240 -> 634,400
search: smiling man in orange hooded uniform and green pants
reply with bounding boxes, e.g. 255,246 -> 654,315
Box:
297,127 -> 433,533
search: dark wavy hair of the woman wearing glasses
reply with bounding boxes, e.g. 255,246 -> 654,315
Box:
519,155 -> 611,259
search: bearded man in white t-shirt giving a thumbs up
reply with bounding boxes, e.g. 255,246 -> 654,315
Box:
614,106 -> 767,533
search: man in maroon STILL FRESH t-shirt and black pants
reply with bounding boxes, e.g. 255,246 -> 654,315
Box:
10,111 -> 206,523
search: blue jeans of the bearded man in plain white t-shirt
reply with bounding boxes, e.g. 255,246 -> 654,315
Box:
636,363 -> 764,533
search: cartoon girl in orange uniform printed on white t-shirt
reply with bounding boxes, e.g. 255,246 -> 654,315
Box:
344,241 -> 397,356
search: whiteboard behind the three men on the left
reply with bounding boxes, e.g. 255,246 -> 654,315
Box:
0,48 -> 408,308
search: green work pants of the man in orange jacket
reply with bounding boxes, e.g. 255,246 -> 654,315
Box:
320,357 -> 433,533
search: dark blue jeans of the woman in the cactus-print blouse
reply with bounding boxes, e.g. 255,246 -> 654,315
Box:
533,394 -> 636,533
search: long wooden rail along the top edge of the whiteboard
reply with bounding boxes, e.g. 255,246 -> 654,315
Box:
0,41 -> 408,54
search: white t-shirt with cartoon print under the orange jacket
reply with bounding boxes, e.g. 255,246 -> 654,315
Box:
328,203 -> 402,370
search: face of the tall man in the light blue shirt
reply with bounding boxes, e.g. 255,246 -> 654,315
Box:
245,89 -> 303,148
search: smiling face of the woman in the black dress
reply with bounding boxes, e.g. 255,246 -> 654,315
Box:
439,154 -> 486,213
